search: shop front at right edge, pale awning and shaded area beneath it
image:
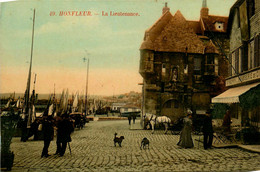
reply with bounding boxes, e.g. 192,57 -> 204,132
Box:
212,82 -> 260,143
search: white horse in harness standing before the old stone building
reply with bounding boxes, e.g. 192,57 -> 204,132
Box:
143,113 -> 171,134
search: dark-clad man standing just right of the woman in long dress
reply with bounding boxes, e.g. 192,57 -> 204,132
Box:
202,110 -> 213,150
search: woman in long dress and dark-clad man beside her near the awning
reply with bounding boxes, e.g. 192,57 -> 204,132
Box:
177,109 -> 213,149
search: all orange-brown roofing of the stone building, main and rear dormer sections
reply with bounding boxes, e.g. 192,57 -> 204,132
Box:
140,10 -> 223,54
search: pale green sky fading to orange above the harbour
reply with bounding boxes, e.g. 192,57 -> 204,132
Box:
0,0 -> 235,95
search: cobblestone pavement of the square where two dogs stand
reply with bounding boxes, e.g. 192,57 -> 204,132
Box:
11,120 -> 260,172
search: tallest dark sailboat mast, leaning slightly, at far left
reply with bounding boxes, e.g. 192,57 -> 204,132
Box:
25,9 -> 35,113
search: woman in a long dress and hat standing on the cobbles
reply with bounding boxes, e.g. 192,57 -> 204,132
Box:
177,109 -> 194,148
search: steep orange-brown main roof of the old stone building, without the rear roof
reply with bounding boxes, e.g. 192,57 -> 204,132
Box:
140,11 -> 205,54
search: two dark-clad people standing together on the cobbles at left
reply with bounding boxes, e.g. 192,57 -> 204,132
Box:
41,113 -> 74,157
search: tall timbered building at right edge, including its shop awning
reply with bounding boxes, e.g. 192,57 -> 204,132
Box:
212,0 -> 260,130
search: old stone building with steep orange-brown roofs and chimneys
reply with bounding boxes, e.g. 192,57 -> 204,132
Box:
139,0 -> 229,120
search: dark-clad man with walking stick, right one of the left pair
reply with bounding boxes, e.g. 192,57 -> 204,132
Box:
55,113 -> 74,156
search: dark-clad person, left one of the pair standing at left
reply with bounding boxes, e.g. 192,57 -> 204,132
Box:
41,115 -> 54,157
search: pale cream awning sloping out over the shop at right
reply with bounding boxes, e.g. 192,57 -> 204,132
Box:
211,82 -> 260,103
